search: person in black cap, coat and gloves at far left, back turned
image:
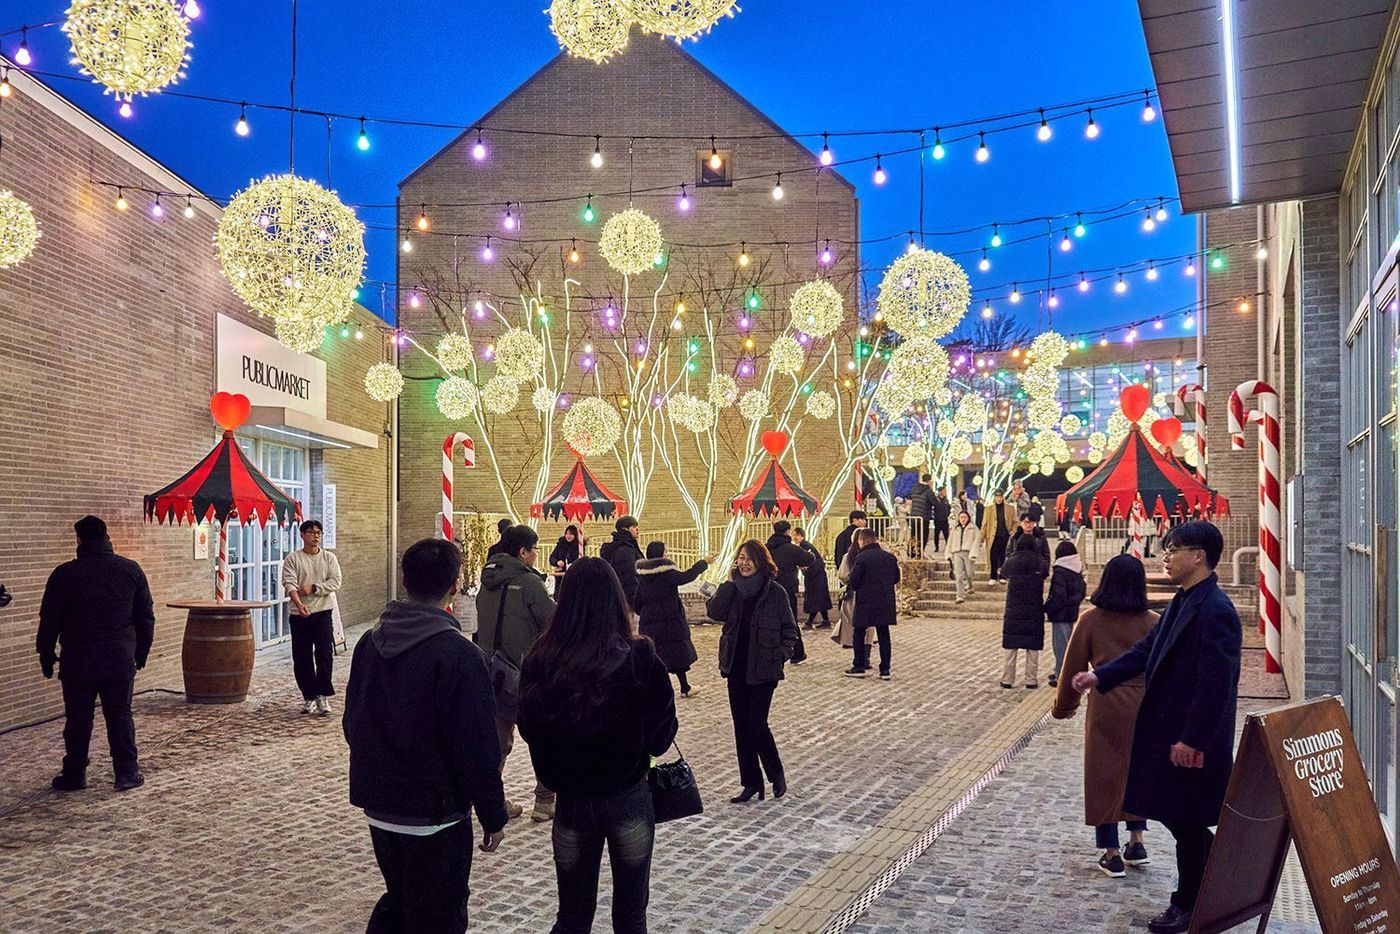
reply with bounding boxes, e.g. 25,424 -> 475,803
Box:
35,515 -> 155,791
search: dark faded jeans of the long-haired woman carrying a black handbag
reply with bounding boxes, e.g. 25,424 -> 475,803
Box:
553,781 -> 657,934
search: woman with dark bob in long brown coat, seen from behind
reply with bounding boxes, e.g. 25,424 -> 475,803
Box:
1051,555 -> 1156,878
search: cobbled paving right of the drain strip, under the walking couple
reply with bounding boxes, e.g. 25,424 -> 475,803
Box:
847,711 -> 1322,934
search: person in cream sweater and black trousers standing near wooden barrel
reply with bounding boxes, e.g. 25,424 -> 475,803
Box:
281,520 -> 340,717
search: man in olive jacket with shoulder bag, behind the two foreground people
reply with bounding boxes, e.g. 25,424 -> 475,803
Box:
476,525 -> 554,822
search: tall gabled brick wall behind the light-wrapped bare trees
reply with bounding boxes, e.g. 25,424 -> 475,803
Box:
399,42 -> 860,548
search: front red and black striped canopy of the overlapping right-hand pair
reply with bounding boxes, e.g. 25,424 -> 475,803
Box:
1056,426 -> 1229,522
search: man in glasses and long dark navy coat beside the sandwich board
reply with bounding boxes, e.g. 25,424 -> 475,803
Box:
1074,521 -> 1240,934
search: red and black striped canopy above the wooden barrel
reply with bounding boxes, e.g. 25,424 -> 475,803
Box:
146,431 -> 301,525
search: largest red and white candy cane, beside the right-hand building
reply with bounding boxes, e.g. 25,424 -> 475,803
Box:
1229,379 -> 1282,674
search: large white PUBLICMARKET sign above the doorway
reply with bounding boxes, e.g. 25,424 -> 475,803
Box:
214,315 -> 326,419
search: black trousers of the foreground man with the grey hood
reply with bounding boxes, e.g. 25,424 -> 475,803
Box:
365,818 -> 475,934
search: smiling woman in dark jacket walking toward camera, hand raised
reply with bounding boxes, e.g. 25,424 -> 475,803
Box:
706,538 -> 798,804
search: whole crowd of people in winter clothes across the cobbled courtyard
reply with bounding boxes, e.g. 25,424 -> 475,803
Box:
27,490 -> 1240,934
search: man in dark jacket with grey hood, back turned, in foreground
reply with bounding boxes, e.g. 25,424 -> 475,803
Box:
343,539 -> 507,934
